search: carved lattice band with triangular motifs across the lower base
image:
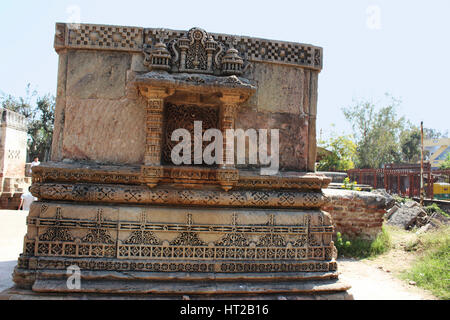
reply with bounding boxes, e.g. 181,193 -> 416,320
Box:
25,205 -> 333,260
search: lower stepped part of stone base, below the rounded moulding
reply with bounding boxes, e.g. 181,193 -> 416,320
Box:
14,201 -> 347,294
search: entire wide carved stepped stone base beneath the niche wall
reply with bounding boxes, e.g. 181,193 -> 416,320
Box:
10,164 -> 348,295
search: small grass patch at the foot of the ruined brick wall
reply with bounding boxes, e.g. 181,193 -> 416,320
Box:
335,226 -> 392,258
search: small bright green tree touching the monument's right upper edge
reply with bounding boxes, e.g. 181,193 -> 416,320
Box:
316,135 -> 356,171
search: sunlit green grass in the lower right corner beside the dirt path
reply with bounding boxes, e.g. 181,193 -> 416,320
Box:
401,227 -> 450,300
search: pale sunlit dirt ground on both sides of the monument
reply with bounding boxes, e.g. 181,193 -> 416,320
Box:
0,210 -> 436,300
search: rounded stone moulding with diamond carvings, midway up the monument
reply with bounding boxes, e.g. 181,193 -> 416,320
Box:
31,183 -> 326,209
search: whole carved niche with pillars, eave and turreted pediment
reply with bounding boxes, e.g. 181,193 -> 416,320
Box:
135,28 -> 256,191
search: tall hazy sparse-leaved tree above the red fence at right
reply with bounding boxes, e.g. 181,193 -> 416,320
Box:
342,95 -> 405,168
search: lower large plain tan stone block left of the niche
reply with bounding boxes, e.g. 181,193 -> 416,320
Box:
62,98 -> 145,164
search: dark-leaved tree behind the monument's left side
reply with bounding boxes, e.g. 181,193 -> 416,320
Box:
0,85 -> 55,161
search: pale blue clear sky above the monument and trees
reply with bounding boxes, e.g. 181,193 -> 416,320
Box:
0,0 -> 450,134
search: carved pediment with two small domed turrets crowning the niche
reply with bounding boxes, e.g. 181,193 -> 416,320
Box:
144,28 -> 244,75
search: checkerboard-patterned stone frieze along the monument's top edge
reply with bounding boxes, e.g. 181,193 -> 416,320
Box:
54,23 -> 322,73
